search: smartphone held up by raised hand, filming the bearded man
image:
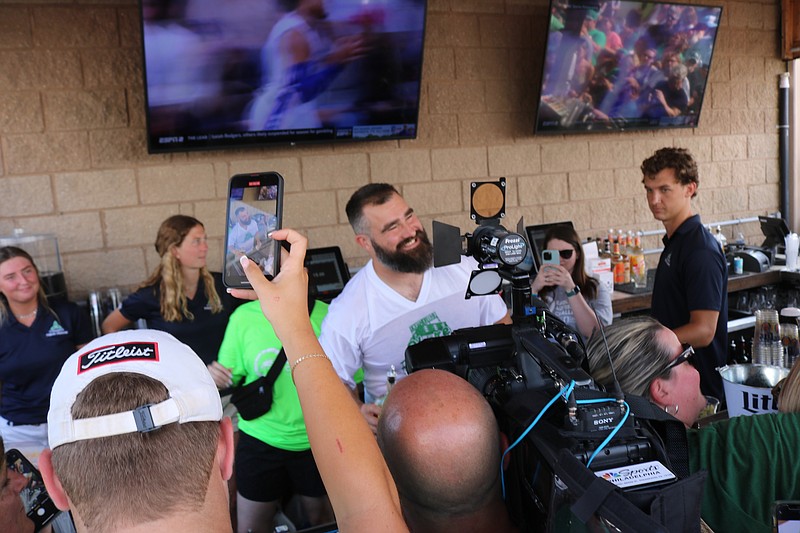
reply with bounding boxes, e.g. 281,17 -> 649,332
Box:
222,172 -> 283,287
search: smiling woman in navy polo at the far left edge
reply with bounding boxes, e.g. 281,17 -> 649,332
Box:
0,246 -> 92,449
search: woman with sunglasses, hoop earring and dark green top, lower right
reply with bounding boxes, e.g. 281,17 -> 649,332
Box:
587,316 -> 800,533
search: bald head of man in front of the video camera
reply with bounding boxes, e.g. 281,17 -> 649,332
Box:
378,370 -> 501,515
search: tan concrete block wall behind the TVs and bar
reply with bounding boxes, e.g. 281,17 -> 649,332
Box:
0,0 -> 785,298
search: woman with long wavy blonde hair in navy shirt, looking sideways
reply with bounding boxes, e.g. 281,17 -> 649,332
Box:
102,215 -> 237,388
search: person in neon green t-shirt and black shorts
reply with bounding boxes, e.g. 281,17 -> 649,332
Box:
218,301 -> 333,533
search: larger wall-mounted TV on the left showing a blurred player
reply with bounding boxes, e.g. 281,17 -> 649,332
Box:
140,0 -> 426,153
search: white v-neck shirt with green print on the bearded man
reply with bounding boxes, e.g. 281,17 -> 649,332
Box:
319,257 -> 508,398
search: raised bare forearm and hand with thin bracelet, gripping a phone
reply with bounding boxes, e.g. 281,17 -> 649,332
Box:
231,229 -> 407,531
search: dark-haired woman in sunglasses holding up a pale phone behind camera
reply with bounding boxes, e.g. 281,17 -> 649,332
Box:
531,226 -> 613,339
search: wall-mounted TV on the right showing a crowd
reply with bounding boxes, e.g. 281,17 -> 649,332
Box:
536,0 -> 722,134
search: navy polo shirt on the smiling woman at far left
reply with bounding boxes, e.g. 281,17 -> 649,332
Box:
0,300 -> 92,424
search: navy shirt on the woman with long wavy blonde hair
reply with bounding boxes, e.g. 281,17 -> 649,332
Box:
120,272 -> 239,365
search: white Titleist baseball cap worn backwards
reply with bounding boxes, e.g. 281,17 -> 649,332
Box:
47,329 -> 222,449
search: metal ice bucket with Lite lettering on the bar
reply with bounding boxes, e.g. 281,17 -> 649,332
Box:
717,365 -> 789,416
